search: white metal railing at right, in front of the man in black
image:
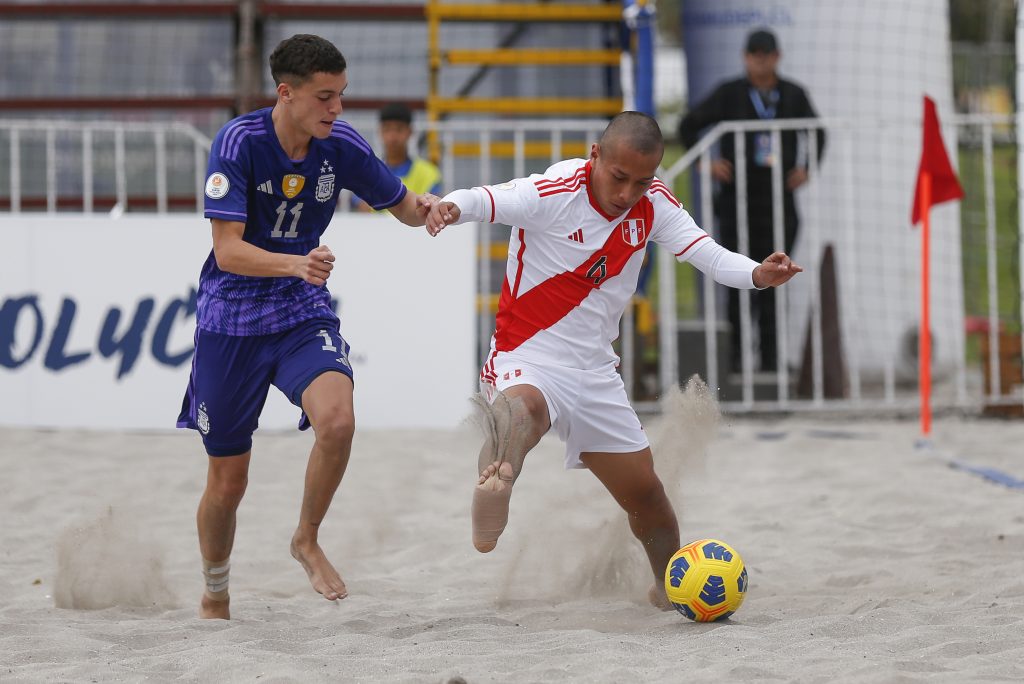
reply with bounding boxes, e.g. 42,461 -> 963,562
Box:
658,115 -> 1024,411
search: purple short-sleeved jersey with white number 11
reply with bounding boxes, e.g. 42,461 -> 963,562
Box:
197,108 -> 406,336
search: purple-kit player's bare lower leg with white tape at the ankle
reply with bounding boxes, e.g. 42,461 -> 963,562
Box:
196,453 -> 250,619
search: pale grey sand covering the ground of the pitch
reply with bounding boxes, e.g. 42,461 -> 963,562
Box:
0,387 -> 1024,683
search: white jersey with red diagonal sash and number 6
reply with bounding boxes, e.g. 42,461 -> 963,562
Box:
474,159 -> 721,381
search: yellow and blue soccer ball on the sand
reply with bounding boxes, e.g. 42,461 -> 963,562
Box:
665,540 -> 746,623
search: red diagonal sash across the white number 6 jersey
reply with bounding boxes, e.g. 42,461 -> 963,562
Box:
495,193 -> 654,351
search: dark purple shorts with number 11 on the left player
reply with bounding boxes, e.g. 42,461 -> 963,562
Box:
177,318 -> 352,456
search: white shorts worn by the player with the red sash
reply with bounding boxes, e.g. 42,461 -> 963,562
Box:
480,352 -> 650,468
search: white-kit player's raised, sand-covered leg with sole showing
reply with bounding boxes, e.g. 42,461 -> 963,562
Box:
472,385 -> 551,553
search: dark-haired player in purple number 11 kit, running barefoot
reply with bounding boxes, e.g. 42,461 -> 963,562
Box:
178,35 -> 437,619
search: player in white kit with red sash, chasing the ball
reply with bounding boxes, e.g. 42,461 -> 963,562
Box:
427,112 -> 803,609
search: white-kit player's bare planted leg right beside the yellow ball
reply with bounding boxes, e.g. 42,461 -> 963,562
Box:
580,447 -> 679,610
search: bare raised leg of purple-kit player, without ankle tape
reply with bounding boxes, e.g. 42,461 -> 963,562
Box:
292,372 -> 355,601
